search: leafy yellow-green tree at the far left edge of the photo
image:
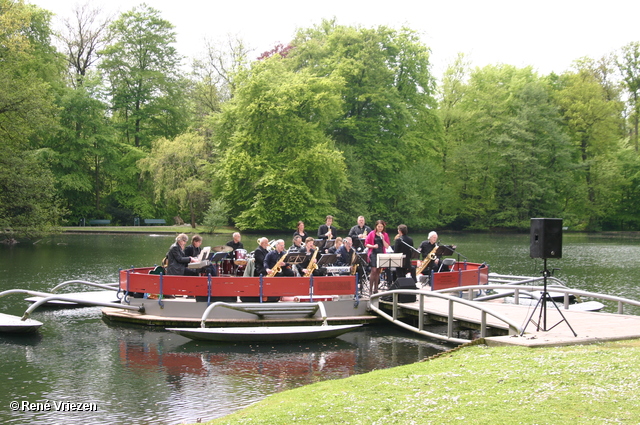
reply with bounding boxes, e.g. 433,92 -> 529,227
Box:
0,0 -> 64,238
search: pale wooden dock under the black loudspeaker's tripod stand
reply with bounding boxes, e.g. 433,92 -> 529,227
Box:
388,297 -> 640,347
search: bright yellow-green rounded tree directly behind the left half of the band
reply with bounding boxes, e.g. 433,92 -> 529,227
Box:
214,56 -> 346,229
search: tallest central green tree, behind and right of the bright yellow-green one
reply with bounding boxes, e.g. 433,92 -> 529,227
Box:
286,20 -> 441,225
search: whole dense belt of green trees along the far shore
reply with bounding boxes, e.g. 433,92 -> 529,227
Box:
0,0 -> 640,242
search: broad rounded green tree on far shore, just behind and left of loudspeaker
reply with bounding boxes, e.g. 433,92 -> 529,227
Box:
441,63 -> 570,229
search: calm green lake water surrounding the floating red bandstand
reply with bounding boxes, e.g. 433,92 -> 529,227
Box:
0,233 -> 640,424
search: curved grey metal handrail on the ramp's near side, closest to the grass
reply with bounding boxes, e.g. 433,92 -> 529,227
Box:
369,285 -> 522,344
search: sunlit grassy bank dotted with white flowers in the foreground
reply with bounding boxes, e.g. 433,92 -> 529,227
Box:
208,340 -> 640,425
